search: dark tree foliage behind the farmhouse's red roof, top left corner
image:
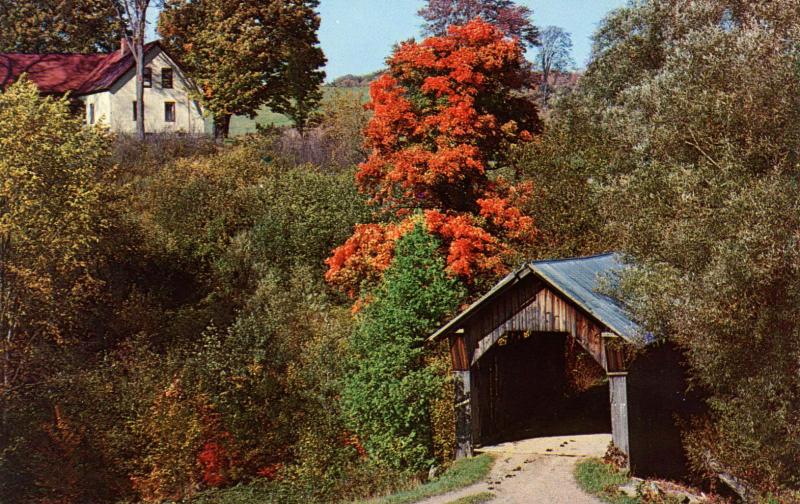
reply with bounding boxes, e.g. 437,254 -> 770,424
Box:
0,0 -> 124,53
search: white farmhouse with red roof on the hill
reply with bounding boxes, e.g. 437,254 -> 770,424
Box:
0,41 -> 205,134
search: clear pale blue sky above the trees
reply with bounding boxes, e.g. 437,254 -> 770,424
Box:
151,0 -> 627,80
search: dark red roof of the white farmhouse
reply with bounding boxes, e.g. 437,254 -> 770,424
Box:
0,41 -> 159,95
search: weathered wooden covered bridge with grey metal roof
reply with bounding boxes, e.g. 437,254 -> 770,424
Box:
430,253 -> 687,477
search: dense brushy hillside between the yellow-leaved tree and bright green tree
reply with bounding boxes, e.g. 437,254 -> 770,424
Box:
0,121 -> 378,502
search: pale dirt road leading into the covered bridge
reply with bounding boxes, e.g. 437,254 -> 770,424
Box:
422,434 -> 611,504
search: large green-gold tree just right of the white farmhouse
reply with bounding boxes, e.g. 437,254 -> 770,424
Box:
158,0 -> 325,137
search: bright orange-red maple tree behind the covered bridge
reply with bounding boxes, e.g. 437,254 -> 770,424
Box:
326,19 -> 541,295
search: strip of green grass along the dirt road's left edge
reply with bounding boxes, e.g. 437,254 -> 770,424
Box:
360,454 -> 494,504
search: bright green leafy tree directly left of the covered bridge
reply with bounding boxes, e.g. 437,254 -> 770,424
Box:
342,223 -> 465,471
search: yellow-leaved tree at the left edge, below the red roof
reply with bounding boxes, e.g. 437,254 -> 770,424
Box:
0,76 -> 110,398
